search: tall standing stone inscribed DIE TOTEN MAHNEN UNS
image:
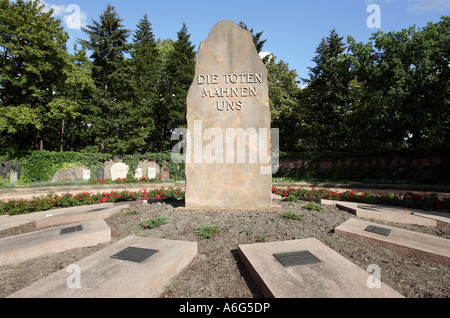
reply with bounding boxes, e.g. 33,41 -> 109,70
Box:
185,21 -> 272,210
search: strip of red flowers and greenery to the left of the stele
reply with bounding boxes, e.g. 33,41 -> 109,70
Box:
0,188 -> 185,215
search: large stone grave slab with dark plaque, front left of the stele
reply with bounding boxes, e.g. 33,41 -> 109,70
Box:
9,236 -> 197,298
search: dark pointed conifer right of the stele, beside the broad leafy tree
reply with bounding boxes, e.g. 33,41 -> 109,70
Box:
302,29 -> 353,150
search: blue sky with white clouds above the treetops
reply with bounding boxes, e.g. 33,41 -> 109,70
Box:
41,0 -> 450,77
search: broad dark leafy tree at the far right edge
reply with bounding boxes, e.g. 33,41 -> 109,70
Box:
349,17 -> 450,149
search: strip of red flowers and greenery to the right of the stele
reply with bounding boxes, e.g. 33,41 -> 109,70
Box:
272,187 -> 450,211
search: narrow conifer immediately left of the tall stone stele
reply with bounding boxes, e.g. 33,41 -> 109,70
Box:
154,23 -> 196,151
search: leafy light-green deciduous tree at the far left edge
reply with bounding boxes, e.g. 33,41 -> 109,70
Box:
0,0 -> 71,150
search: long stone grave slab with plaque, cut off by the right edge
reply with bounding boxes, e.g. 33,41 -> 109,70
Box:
334,218 -> 450,265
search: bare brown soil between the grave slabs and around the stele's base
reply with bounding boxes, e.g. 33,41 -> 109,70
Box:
0,202 -> 450,298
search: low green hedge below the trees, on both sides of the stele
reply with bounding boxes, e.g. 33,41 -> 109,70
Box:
0,149 -> 450,184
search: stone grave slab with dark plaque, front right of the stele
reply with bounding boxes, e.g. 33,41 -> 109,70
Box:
238,238 -> 403,298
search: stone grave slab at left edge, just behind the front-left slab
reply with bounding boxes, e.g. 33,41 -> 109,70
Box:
0,219 -> 111,266
